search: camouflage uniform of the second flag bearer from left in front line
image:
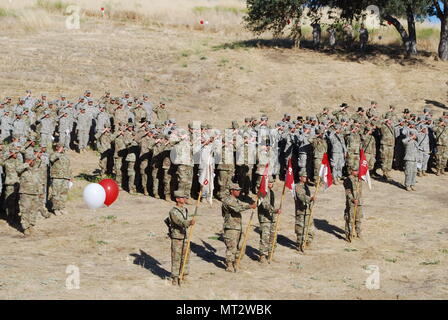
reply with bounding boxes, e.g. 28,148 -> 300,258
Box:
221,191 -> 250,266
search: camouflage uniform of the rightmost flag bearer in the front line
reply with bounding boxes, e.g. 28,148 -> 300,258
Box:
344,174 -> 363,238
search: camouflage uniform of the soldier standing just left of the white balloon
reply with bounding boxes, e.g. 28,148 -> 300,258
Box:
49,152 -> 72,214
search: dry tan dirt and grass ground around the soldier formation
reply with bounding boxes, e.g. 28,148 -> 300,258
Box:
0,15 -> 448,299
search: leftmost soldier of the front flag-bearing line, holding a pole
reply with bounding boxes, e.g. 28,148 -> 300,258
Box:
165,190 -> 195,285
